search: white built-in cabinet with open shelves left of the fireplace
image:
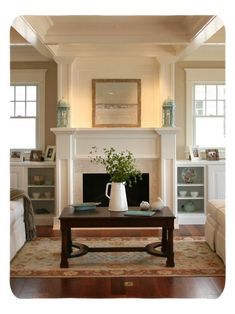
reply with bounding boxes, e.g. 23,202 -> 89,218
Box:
10,161 -> 56,225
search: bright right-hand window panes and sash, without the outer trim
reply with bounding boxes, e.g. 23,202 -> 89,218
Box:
193,84 -> 225,147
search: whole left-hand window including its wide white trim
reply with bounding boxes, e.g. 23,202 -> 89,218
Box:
10,69 -> 46,150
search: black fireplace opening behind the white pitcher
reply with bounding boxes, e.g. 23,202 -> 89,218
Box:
83,173 -> 149,206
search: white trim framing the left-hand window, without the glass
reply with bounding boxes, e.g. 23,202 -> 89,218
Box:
11,69 -> 47,150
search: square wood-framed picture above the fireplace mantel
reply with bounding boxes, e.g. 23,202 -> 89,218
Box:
92,79 -> 141,127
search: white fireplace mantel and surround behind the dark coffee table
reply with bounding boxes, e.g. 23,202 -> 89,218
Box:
52,128 -> 179,229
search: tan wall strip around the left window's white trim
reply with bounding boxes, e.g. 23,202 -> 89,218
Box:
11,61 -> 57,148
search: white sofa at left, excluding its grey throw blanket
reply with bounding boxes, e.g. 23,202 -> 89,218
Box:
10,198 -> 26,260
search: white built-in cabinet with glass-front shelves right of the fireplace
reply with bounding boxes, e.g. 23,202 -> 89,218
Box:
175,160 -> 225,224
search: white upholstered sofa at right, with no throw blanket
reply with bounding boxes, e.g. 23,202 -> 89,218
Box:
205,199 -> 225,263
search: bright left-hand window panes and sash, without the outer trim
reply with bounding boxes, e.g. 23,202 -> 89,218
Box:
10,85 -> 38,149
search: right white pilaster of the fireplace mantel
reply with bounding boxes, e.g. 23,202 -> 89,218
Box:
156,128 -> 180,213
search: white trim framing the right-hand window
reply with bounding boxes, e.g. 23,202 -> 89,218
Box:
185,68 -> 225,147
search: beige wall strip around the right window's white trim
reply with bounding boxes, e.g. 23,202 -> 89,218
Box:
175,61 -> 225,159
